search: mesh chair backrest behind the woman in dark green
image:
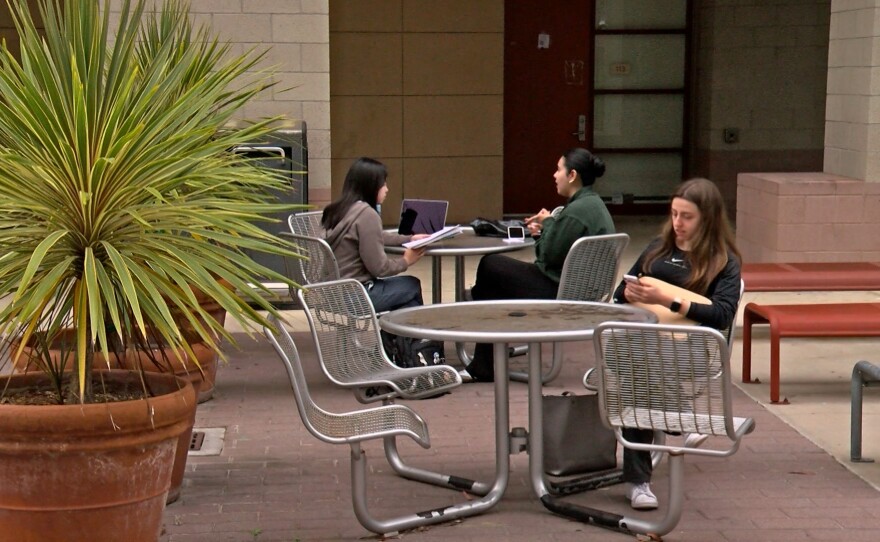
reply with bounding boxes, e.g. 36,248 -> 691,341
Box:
556,233 -> 629,301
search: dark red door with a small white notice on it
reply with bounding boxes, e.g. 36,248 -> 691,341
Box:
503,0 -> 593,214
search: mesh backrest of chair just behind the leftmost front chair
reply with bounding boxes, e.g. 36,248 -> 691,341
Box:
297,279 -> 395,385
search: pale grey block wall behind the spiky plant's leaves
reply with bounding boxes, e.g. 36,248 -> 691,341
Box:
112,0 -> 331,202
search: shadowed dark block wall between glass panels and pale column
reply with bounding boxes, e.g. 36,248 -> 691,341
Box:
691,0 -> 830,217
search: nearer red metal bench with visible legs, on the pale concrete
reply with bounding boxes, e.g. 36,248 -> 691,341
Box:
742,304 -> 880,403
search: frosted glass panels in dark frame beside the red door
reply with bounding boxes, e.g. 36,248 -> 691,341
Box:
591,0 -> 692,213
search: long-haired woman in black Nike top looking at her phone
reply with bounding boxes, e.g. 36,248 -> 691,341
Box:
614,179 -> 742,510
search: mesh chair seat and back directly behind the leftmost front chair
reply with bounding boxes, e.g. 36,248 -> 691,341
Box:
297,279 -> 461,403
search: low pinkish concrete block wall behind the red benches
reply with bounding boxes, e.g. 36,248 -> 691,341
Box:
736,173 -> 880,262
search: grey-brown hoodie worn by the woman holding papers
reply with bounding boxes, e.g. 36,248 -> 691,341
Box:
324,201 -> 410,282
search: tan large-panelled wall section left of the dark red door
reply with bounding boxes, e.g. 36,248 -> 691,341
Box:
328,0 -> 504,224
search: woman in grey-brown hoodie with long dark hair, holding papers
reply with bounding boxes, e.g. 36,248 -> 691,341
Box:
321,158 -> 425,312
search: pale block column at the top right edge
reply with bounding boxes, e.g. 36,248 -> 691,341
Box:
824,0 -> 880,182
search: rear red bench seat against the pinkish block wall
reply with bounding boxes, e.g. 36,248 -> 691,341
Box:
742,262 -> 880,292
